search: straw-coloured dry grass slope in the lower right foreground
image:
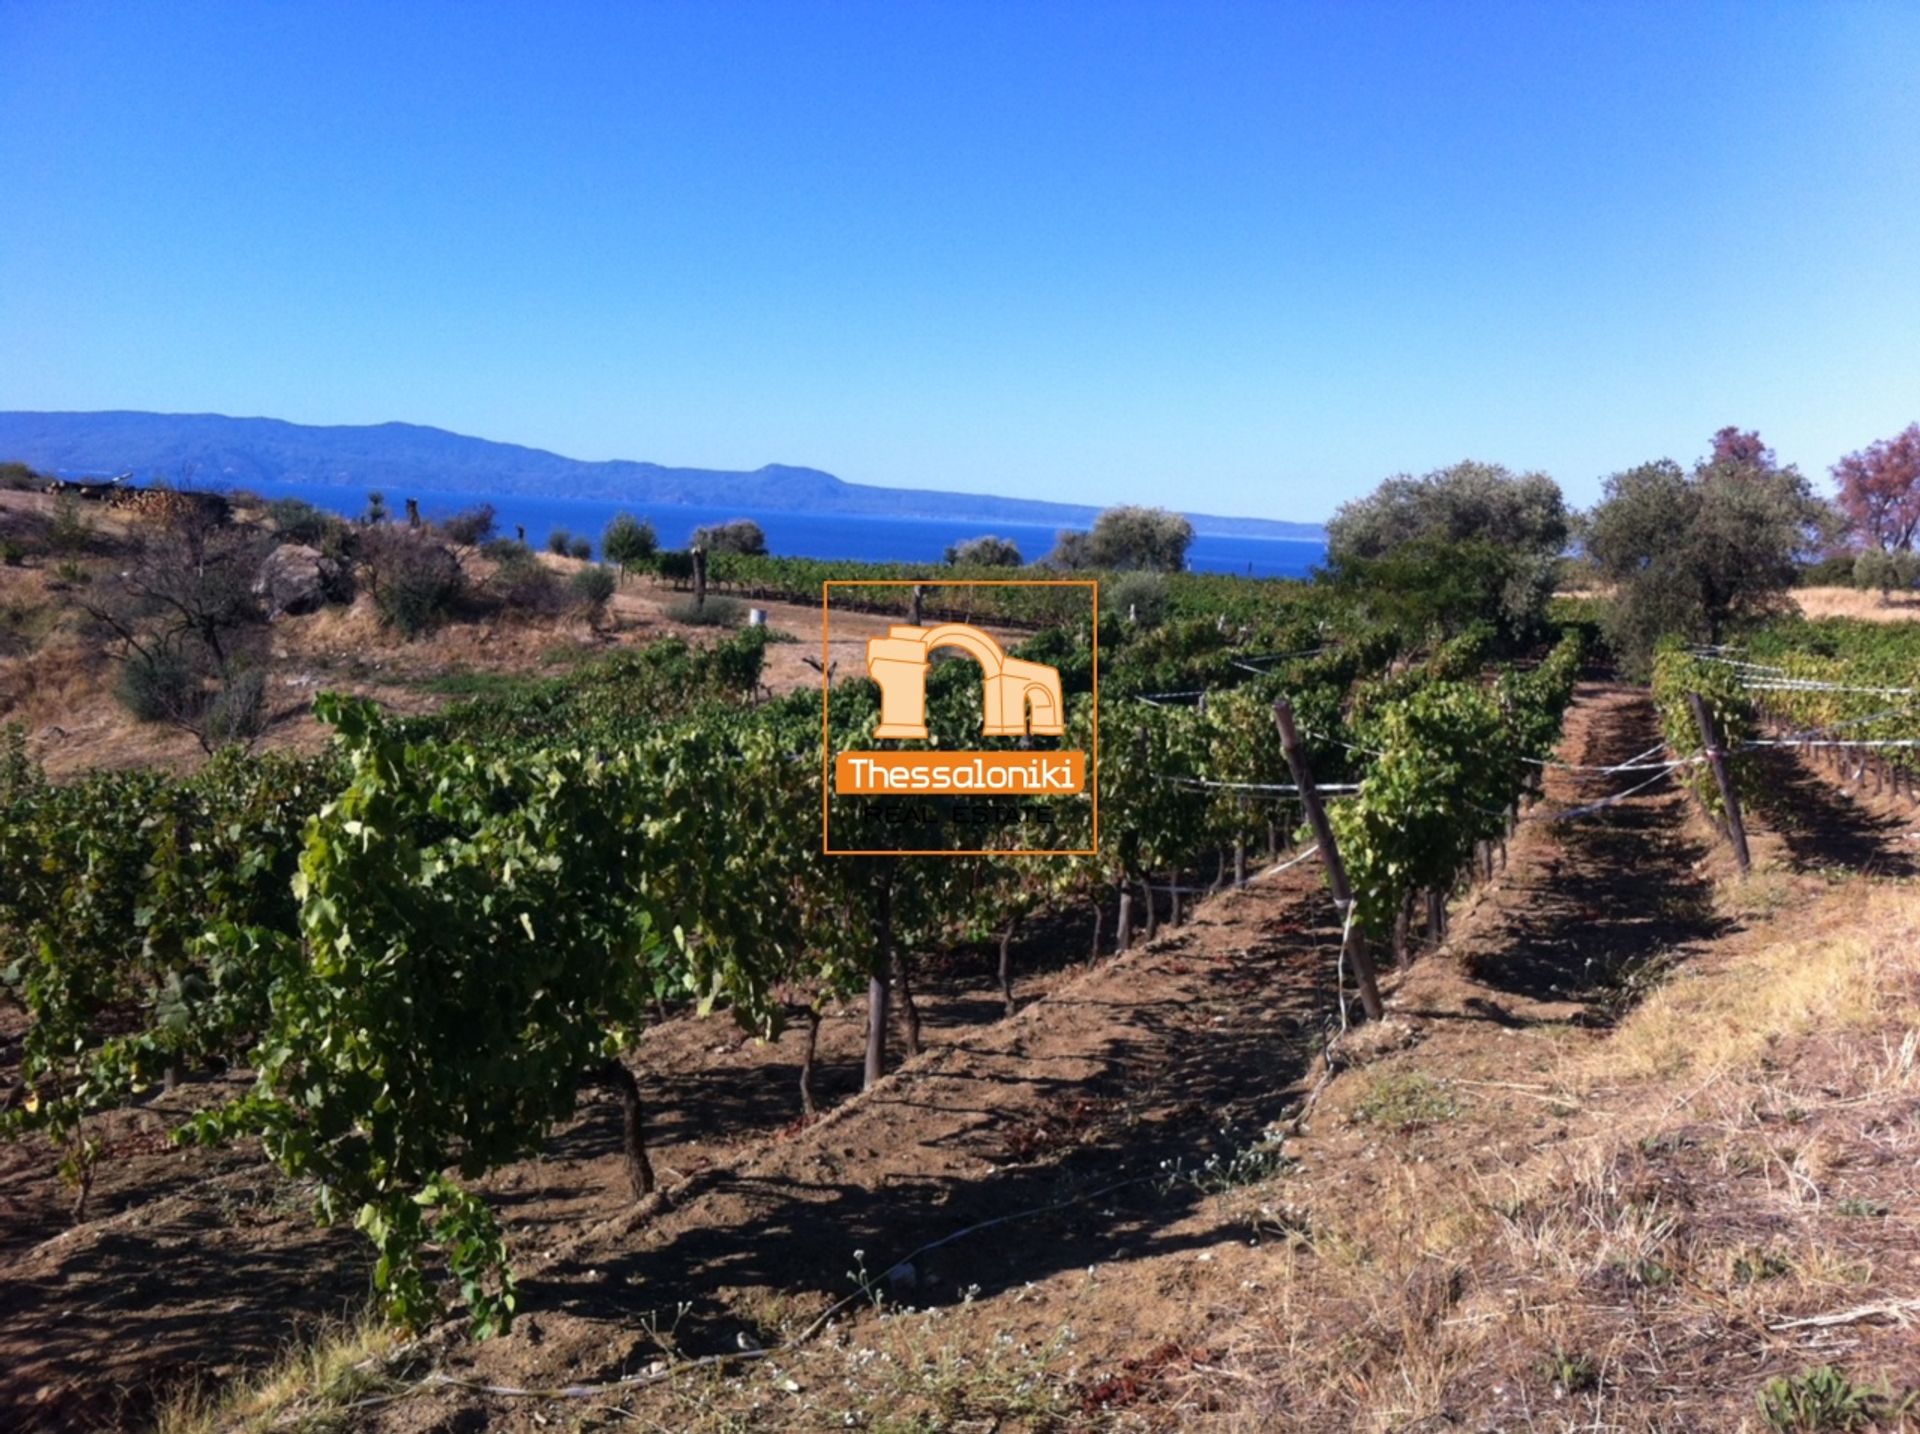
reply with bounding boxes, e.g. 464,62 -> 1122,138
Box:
1196,883 -> 1920,1430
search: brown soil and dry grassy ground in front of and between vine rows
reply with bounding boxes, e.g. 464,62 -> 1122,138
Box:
0,683 -> 1920,1430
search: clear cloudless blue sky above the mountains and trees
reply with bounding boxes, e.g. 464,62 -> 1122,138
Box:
0,0 -> 1920,518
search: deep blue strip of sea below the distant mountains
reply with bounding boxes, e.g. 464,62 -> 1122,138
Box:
206,482 -> 1327,578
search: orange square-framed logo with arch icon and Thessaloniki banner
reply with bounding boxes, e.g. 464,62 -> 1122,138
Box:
820,580 -> 1098,856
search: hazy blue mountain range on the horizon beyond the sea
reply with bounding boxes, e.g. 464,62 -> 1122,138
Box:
0,411 -> 1323,539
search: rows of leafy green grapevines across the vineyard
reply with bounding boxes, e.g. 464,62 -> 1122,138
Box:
0,575 -> 1920,1428
